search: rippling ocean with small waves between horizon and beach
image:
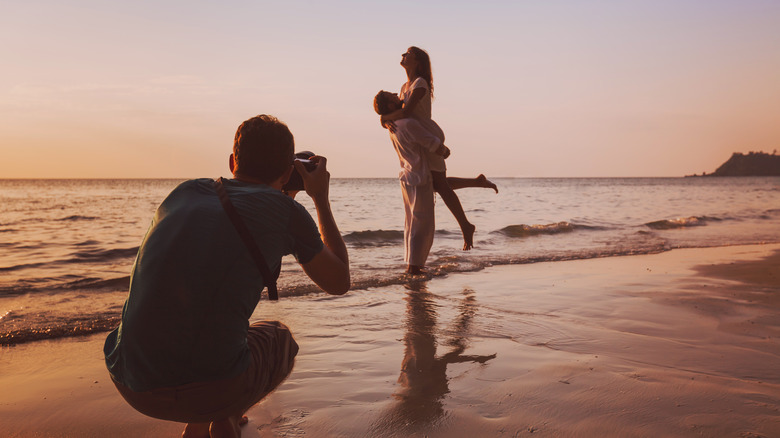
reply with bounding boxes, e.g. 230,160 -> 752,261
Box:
0,177 -> 780,345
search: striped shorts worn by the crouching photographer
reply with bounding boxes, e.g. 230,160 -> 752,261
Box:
114,321 -> 298,423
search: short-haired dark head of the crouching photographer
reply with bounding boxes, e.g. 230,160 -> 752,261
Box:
233,114 -> 295,183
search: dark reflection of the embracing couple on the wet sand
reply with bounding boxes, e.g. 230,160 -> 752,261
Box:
374,282 -> 496,436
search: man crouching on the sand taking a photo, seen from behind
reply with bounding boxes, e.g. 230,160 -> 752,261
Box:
104,115 -> 350,438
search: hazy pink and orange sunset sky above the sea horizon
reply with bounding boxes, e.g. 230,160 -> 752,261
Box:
0,0 -> 780,178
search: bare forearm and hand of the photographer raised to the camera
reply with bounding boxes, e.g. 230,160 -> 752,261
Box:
294,156 -> 350,295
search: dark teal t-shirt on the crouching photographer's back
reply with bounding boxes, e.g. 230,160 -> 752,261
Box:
104,178 -> 323,392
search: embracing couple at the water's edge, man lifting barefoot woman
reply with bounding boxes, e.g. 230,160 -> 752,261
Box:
374,46 -> 498,275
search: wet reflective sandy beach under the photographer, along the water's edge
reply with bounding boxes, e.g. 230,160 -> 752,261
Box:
0,245 -> 780,437
